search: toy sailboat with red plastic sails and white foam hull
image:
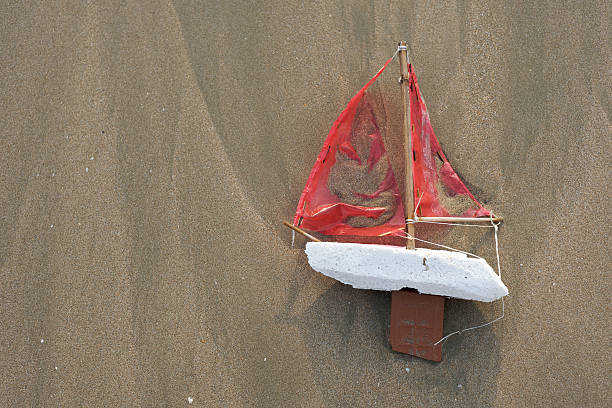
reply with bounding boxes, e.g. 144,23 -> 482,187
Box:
291,43 -> 508,361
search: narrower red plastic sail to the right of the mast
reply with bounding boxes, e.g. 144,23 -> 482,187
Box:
408,64 -> 490,217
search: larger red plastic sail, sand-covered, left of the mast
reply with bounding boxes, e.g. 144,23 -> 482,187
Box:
293,59 -> 406,236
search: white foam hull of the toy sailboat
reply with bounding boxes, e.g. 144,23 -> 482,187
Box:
306,242 -> 508,302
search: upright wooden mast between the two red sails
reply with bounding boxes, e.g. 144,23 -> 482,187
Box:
399,41 -> 415,249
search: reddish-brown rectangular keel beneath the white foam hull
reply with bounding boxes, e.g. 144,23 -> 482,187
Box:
389,290 -> 444,362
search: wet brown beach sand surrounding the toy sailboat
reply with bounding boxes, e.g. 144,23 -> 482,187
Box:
0,1 -> 612,407
